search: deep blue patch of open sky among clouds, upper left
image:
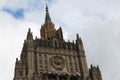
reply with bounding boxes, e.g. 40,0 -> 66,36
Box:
3,8 -> 24,19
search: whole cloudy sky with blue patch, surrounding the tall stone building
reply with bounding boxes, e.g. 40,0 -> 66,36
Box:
0,0 -> 120,80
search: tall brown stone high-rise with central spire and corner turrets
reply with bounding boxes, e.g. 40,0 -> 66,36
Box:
13,6 -> 102,80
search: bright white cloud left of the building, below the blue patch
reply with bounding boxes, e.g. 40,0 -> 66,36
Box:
0,10 -> 39,80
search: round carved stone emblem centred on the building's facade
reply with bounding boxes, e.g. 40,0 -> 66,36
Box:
51,56 -> 65,70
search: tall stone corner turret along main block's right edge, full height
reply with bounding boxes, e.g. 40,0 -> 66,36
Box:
76,34 -> 89,80
